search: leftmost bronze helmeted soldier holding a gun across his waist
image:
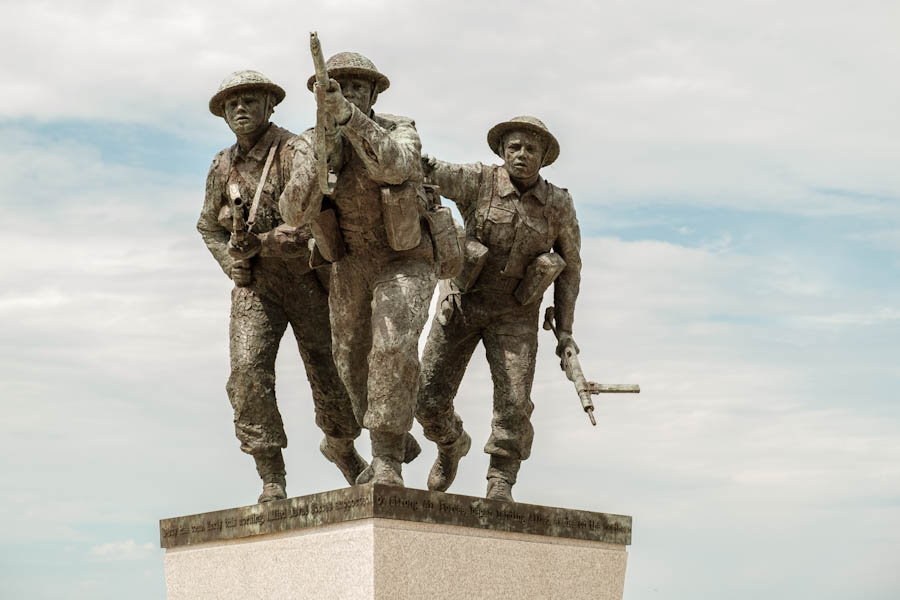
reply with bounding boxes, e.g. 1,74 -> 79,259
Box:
197,71 -> 367,502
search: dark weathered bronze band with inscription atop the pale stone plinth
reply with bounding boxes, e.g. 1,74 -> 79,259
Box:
159,483 -> 631,548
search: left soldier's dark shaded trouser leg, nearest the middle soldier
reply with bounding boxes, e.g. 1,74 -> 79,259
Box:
285,273 -> 360,440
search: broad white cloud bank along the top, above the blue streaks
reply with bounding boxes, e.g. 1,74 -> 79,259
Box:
0,0 -> 900,217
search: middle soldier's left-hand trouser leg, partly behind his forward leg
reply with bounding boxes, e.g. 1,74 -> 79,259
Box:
328,256 -> 372,425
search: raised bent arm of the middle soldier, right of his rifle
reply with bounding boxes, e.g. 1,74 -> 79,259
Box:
341,105 -> 422,185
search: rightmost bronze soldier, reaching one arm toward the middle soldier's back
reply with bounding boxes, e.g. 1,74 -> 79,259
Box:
416,116 -> 581,501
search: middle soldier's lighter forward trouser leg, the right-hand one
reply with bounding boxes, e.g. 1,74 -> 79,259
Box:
362,260 -> 436,434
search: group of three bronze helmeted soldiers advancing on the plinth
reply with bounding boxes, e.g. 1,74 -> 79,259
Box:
197,52 -> 581,502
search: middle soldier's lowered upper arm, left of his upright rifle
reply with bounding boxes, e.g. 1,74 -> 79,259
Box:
278,130 -> 322,227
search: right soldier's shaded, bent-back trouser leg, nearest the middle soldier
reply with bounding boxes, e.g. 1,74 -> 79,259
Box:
416,314 -> 481,444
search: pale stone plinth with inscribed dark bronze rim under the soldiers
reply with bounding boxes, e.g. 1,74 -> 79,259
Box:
160,484 -> 631,600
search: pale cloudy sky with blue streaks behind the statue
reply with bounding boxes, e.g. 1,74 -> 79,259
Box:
0,0 -> 900,600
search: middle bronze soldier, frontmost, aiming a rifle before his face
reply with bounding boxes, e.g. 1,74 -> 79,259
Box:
281,52 -> 436,485
